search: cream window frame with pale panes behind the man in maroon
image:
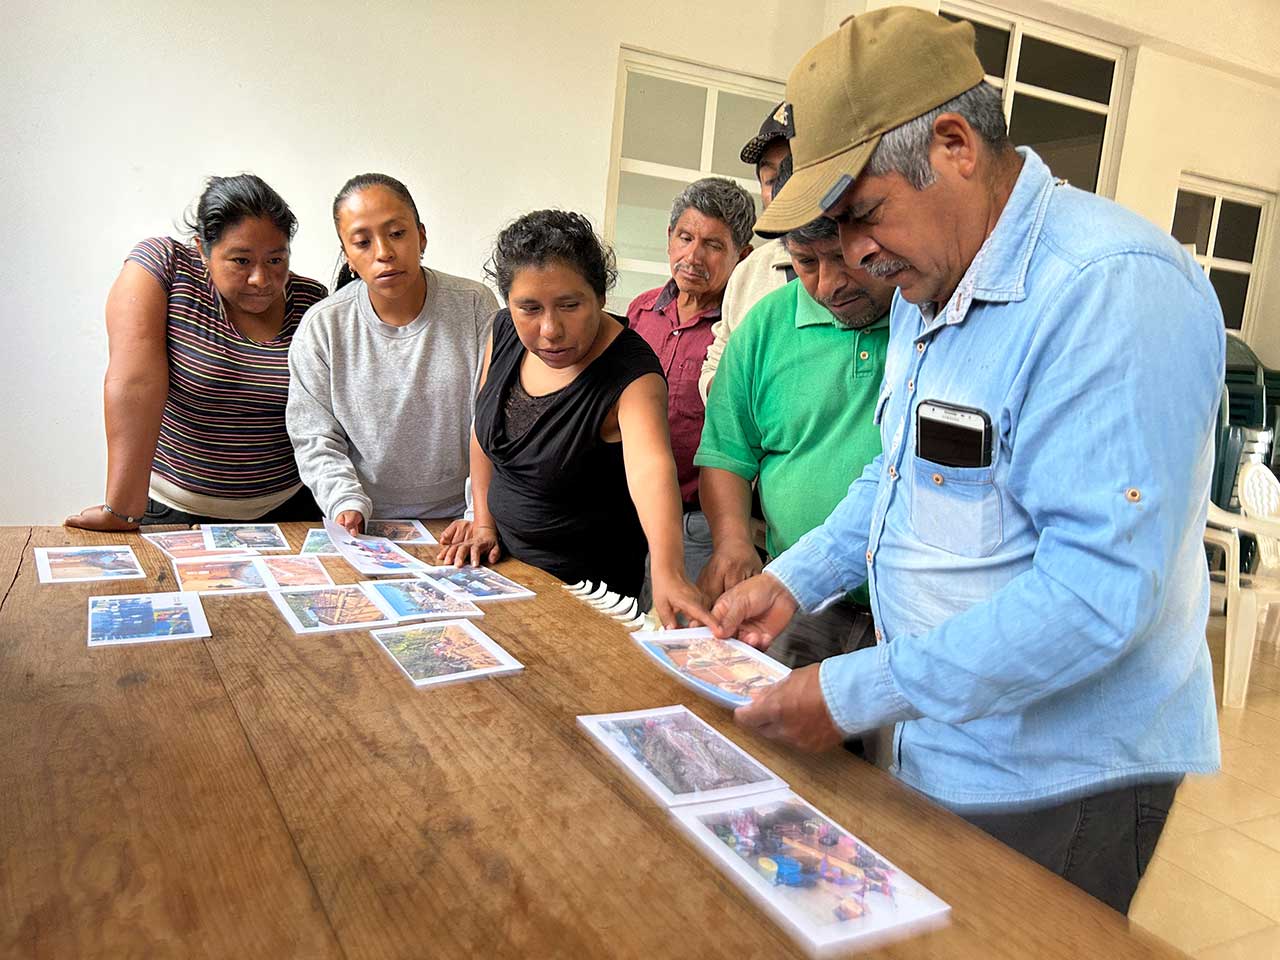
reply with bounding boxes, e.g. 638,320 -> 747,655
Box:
604,45 -> 786,285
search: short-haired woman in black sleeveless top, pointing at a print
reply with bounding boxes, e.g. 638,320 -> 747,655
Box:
440,210 -> 707,626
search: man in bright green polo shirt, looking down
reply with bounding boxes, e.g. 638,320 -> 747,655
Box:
694,218 -> 893,667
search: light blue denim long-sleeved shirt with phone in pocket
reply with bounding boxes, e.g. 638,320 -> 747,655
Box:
767,148 -> 1225,809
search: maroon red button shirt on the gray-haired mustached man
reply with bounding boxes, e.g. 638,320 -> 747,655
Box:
627,280 -> 719,506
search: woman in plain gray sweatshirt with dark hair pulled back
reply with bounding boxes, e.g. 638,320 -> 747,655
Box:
285,174 -> 498,532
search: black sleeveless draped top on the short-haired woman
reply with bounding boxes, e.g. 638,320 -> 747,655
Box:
476,310 -> 662,596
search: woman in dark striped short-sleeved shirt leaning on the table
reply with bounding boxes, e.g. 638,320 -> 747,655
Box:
65,174 -> 326,530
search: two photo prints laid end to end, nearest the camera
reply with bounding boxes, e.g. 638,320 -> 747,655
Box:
577,701 -> 951,955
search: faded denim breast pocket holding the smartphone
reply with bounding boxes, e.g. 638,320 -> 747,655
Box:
911,457 -> 1005,557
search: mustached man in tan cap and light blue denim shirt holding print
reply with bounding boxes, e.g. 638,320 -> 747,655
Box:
712,8 -> 1225,911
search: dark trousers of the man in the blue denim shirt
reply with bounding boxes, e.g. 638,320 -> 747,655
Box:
961,777 -> 1181,914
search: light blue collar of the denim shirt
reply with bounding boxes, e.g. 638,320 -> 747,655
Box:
920,147 -> 1056,335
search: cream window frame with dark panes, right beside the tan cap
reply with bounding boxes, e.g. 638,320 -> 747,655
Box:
940,0 -> 1126,198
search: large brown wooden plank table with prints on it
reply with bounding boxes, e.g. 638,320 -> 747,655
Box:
0,524 -> 1181,960
